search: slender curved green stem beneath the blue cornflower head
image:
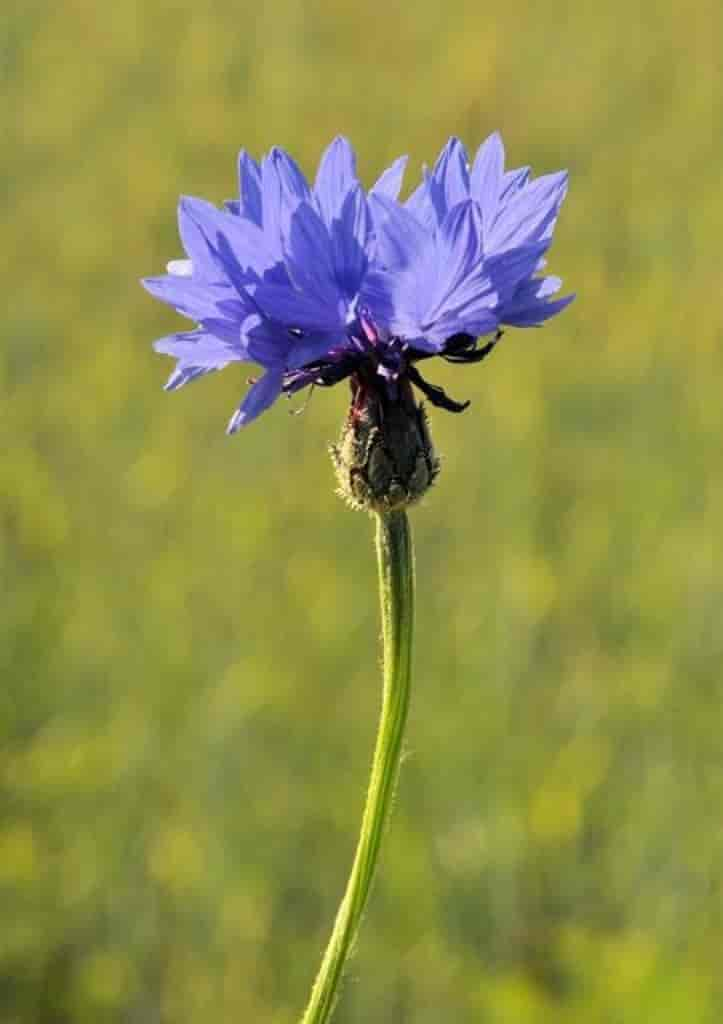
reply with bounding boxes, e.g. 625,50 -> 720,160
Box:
302,510 -> 414,1024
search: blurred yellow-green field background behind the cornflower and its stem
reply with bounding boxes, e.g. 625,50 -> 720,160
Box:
0,0 -> 723,1024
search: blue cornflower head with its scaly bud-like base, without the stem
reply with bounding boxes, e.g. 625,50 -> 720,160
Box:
143,134 -> 572,506
